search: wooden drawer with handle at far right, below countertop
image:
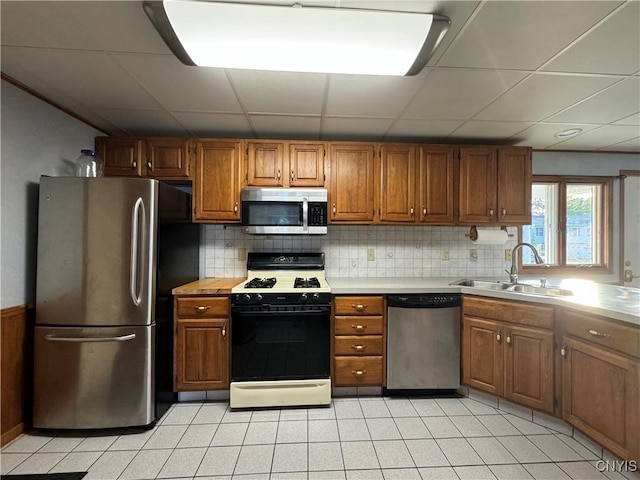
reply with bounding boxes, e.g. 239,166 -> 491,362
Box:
561,310 -> 640,357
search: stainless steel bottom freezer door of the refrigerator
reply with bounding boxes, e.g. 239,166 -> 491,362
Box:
33,325 -> 155,429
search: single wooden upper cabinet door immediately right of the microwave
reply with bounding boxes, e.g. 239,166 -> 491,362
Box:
329,143 -> 374,223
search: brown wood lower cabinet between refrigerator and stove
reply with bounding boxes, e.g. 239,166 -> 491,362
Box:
174,296 -> 229,392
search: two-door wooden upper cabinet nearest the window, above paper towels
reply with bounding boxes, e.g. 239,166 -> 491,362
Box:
458,147 -> 532,225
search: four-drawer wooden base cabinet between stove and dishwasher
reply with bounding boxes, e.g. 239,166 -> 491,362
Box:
332,295 -> 386,387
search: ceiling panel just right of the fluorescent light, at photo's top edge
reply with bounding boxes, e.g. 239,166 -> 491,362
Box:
440,1 -> 621,70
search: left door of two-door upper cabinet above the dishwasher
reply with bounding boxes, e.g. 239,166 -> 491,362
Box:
380,144 -> 416,223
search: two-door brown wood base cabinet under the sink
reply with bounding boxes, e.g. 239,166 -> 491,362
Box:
462,296 -> 555,413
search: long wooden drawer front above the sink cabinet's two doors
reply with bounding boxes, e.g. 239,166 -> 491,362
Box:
462,295 -> 555,329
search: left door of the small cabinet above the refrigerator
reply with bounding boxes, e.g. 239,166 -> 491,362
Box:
96,137 -> 142,177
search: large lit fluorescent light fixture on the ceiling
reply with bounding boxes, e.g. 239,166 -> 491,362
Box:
144,0 -> 451,75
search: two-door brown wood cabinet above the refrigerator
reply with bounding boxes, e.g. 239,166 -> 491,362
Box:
96,137 -> 193,180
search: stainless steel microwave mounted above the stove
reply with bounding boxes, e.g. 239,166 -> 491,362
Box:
240,187 -> 327,235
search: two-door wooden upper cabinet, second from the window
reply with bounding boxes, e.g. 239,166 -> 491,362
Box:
379,143 -> 455,225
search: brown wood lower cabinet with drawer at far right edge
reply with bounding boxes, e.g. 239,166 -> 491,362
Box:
559,310 -> 640,461
